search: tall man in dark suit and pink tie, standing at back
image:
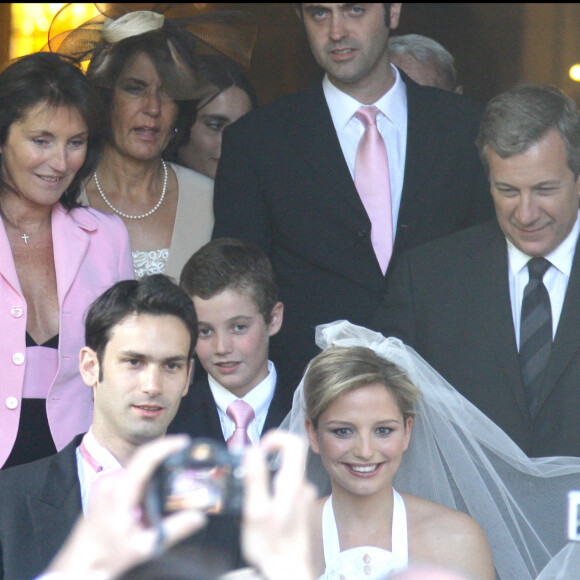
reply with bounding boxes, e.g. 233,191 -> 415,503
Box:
213,3 -> 493,408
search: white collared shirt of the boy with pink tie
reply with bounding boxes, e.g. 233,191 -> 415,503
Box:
207,361 -> 277,445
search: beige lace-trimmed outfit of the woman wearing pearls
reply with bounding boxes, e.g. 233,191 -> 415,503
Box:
79,163 -> 214,281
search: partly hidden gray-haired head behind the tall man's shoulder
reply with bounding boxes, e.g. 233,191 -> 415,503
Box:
389,34 -> 463,94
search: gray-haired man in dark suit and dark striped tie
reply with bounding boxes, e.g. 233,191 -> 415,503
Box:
374,85 -> 580,457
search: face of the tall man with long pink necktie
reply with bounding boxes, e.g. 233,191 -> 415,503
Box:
302,3 -> 401,102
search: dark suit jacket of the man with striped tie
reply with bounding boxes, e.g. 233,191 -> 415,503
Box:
373,219 -> 580,457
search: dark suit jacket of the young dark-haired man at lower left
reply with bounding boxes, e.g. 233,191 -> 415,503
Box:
0,435 -> 241,580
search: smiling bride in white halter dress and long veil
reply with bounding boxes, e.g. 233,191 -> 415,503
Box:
282,321 -> 580,580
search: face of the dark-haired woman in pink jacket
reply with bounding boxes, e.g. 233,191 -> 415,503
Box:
0,101 -> 88,211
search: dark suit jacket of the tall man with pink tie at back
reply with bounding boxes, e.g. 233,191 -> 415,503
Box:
213,75 -> 493,409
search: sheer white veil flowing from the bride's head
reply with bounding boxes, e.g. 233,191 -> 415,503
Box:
281,320 -> 580,580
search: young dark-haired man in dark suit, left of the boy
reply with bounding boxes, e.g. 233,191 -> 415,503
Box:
0,274 -> 239,580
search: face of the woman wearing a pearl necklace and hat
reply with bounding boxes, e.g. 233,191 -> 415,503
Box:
111,52 -> 178,161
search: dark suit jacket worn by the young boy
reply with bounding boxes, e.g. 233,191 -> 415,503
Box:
168,361 -> 286,443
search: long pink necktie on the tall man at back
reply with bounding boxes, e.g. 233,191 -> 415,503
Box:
354,106 -> 393,274
